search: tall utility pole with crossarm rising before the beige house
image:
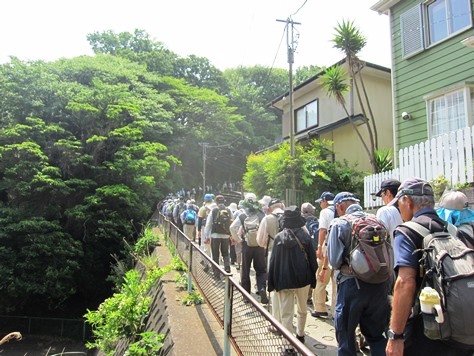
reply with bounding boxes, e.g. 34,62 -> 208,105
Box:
277,16 -> 301,192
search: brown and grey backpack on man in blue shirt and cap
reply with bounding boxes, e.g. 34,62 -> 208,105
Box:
341,214 -> 393,284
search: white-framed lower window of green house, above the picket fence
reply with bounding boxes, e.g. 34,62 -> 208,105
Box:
428,88 -> 472,137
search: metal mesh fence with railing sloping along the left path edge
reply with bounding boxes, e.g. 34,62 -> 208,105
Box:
158,214 -> 314,356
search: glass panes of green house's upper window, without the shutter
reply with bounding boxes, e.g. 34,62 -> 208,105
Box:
426,0 -> 471,44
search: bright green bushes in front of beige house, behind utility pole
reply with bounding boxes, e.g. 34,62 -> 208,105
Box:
244,140 -> 364,201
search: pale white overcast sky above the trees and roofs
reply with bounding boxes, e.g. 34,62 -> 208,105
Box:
0,0 -> 391,70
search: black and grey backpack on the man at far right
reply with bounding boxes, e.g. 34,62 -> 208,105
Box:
401,221 -> 474,348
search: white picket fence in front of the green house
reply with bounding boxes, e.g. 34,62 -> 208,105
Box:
364,126 -> 474,208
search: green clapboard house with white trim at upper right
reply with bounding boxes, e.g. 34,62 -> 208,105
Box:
371,0 -> 474,152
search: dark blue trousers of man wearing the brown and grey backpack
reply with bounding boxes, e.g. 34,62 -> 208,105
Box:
334,278 -> 390,356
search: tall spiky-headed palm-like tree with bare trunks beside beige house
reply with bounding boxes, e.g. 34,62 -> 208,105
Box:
323,21 -> 378,173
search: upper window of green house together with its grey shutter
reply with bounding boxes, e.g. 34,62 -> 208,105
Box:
400,0 -> 472,58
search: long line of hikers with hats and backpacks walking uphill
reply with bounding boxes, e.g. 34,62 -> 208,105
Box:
159,178 -> 474,356
